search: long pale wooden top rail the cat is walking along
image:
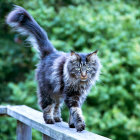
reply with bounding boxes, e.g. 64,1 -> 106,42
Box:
0,105 -> 109,140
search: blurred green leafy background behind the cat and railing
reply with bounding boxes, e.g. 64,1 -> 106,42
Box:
0,0 -> 140,140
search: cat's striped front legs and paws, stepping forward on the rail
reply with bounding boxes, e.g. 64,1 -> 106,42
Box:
65,96 -> 85,131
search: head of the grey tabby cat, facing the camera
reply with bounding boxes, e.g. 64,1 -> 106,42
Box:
67,51 -> 100,81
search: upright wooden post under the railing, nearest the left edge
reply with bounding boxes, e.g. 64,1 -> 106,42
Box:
16,121 -> 32,140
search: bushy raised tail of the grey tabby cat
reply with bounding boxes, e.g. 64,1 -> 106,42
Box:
6,6 -> 56,57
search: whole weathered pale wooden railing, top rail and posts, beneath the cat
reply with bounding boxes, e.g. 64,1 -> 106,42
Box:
0,105 -> 110,140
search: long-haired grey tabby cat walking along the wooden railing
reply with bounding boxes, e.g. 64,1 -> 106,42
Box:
6,6 -> 101,132
